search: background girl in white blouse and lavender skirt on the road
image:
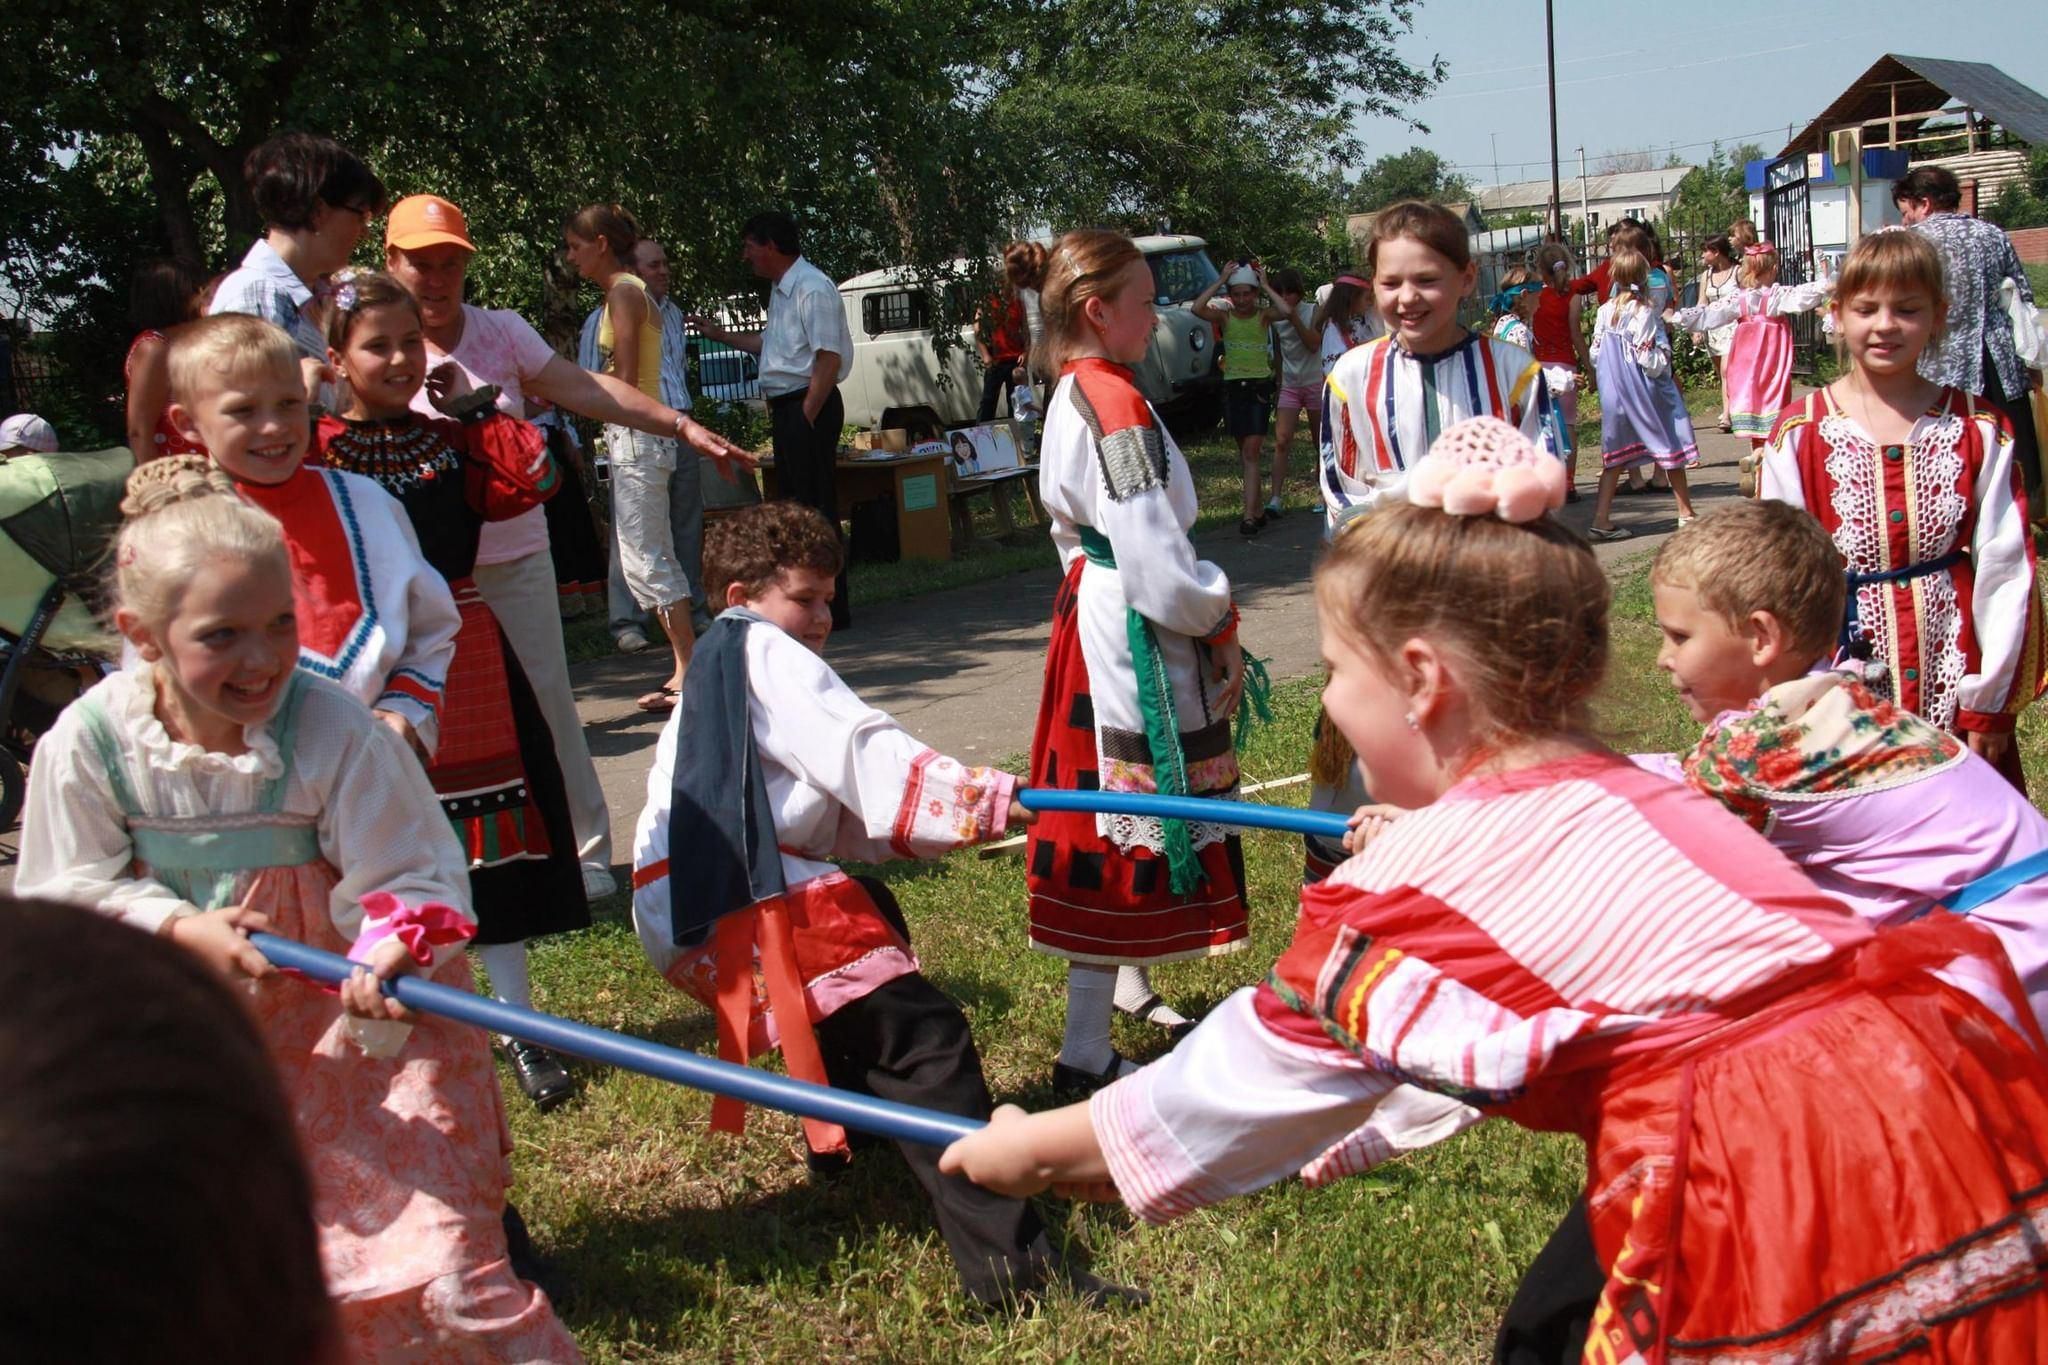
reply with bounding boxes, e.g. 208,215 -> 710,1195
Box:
1587,246 -> 1700,540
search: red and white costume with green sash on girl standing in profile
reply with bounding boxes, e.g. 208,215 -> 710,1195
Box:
1028,360 -> 1245,962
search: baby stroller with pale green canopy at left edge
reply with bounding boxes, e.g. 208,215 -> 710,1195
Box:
0,446 -> 135,829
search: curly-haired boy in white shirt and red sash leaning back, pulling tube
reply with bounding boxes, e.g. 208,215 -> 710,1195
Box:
633,501 -> 1130,1304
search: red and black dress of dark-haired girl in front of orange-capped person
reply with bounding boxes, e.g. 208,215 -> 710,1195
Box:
313,403 -> 590,943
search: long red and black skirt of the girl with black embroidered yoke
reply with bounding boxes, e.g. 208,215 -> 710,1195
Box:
426,579 -> 590,943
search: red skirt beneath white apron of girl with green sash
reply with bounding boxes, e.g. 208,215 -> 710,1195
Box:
1026,557 -> 1247,964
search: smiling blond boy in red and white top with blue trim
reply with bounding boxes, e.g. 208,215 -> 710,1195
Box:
170,313 -> 463,757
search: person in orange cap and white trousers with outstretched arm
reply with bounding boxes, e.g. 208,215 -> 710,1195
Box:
385,194 -> 754,1109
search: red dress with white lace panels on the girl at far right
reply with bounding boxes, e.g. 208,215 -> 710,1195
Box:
1759,389 -> 2044,733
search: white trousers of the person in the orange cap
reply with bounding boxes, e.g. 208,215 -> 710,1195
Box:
475,551 -> 612,868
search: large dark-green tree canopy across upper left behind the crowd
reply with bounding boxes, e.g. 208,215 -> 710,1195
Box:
0,0 -> 1442,437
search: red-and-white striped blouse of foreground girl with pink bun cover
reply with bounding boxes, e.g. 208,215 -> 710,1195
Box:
1090,753 -> 1872,1222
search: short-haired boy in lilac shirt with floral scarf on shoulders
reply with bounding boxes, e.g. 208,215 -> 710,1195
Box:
1636,501 -> 2048,1025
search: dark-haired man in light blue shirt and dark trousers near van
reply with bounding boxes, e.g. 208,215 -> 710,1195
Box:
690,213 -> 854,630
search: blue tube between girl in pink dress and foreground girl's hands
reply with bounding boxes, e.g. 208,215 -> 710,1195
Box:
250,933 -> 981,1146
